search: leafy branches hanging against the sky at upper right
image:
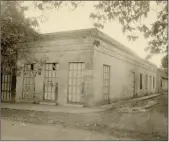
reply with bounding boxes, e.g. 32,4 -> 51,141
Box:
90,1 -> 168,58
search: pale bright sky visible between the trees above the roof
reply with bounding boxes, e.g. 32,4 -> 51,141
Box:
25,1 -> 162,67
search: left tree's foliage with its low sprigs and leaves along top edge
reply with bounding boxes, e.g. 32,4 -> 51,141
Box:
1,1 -> 83,73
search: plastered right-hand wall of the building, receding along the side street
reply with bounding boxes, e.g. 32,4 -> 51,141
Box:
94,42 -> 156,105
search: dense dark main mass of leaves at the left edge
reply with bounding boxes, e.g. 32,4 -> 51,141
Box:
1,1 -> 39,74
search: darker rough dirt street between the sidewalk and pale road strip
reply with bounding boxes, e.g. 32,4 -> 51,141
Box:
1,95 -> 168,140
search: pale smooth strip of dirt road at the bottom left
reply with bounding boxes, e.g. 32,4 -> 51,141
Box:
1,119 -> 129,140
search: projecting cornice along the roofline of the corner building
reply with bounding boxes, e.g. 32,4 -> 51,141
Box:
18,28 -> 156,67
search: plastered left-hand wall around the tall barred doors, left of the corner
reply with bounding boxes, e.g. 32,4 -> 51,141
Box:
16,39 -> 94,106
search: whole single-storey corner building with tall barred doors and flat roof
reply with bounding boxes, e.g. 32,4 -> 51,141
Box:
9,29 -> 167,107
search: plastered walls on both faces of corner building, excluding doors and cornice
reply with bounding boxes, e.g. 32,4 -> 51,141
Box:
16,35 -> 162,106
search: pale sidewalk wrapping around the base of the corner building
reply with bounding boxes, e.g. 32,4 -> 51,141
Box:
1,94 -> 161,114
